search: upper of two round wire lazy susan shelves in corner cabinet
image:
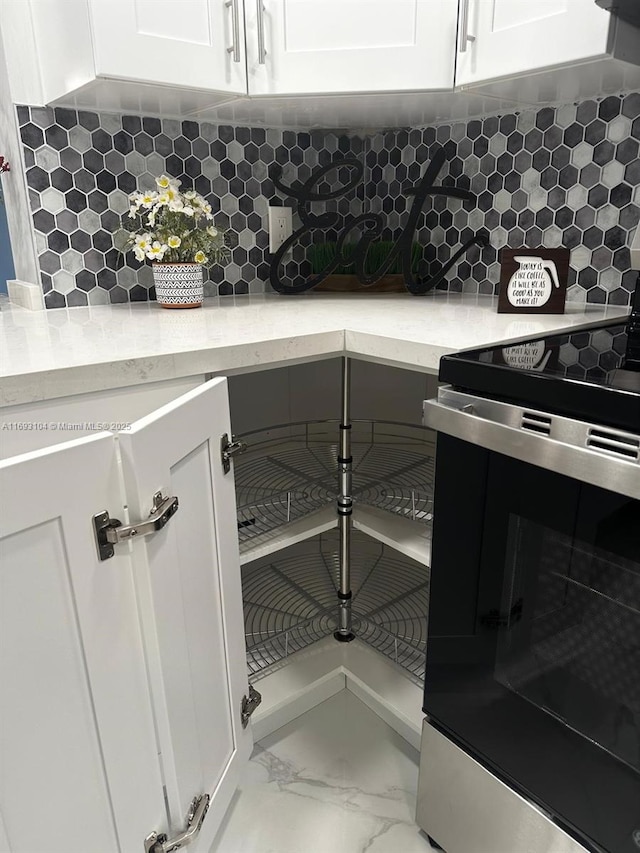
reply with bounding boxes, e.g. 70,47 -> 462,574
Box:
235,421 -> 434,552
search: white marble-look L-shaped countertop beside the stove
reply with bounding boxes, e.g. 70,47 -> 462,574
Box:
0,291 -> 629,406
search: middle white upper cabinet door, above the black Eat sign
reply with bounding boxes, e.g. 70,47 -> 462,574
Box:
245,0 -> 458,95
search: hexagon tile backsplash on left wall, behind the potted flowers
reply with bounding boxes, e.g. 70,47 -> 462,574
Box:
18,107 -> 356,308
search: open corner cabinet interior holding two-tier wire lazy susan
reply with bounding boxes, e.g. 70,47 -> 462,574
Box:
231,362 -> 435,692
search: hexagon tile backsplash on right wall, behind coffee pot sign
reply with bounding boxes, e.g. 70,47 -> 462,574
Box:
366,92 -> 640,305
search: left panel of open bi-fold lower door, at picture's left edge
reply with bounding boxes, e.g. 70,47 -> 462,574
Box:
0,433 -> 165,853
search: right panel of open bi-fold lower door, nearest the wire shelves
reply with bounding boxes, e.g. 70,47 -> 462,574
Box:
118,379 -> 252,850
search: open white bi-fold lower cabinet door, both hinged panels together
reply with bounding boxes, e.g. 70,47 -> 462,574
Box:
0,379 -> 252,853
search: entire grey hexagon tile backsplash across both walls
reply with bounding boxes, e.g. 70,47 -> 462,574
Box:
18,93 -> 640,308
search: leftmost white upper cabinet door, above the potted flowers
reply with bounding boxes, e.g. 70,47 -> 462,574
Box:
89,0 -> 247,93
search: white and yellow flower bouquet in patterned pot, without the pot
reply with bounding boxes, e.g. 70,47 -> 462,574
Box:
124,175 -> 229,264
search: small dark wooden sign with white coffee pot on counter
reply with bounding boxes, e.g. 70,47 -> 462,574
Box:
498,247 -> 569,314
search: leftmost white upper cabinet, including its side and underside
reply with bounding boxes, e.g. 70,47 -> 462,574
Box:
1,0 -> 247,109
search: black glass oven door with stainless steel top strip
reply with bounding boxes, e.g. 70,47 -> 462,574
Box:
424,390 -> 640,853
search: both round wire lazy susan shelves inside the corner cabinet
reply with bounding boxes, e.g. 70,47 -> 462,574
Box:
235,420 -> 435,683
